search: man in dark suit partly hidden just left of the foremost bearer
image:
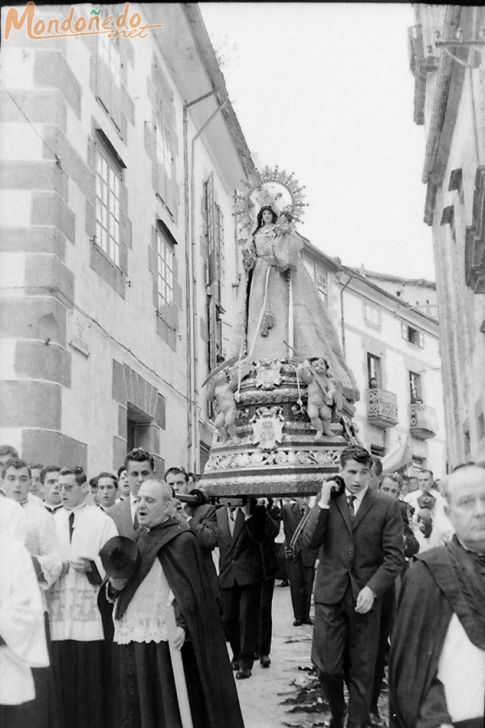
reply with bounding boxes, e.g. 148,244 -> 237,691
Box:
281,497 -> 318,627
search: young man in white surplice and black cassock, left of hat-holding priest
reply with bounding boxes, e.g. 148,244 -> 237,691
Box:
48,467 -> 118,728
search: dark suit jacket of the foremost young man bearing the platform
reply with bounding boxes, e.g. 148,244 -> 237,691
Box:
300,488 -> 404,604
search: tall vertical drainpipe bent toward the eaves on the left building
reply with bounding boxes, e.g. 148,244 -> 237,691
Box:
183,90 -> 229,472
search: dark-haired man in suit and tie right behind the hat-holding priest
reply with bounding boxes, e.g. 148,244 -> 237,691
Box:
106,447 -> 155,541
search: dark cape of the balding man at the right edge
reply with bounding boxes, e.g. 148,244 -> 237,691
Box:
389,536 -> 485,728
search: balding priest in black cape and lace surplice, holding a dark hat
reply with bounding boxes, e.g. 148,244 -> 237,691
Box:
105,480 -> 244,728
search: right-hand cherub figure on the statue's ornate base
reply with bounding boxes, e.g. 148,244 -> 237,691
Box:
298,357 -> 342,440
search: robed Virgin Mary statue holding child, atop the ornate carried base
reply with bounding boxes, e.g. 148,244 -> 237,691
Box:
229,205 -> 359,401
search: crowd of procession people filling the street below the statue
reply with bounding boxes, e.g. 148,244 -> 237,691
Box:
0,445 -> 485,728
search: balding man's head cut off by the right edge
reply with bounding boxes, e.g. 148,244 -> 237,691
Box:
441,465 -> 485,553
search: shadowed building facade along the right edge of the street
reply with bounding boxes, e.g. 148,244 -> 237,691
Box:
409,4 -> 485,466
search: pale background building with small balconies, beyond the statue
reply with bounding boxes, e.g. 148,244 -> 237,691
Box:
304,241 -> 446,476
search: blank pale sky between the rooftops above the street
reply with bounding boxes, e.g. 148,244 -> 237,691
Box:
200,2 -> 435,280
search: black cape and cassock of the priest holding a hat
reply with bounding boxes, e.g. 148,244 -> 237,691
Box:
105,519 -> 244,728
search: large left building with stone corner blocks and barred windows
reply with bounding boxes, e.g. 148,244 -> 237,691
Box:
0,3 -> 253,474
